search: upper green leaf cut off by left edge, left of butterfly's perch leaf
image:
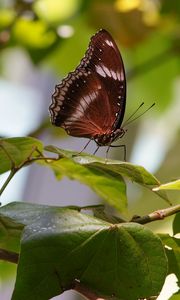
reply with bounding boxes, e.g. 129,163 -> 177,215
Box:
0,137 -> 43,174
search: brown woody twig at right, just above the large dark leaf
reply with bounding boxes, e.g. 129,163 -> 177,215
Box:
130,204 -> 180,224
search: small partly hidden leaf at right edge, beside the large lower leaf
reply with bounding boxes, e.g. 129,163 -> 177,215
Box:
159,234 -> 180,284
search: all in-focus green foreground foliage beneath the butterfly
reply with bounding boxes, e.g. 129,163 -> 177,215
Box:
0,137 -> 180,300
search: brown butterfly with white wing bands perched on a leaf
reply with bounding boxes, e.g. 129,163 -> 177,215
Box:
49,29 -> 126,155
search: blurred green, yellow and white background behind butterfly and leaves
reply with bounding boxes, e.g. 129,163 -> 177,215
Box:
0,0 -> 180,300
